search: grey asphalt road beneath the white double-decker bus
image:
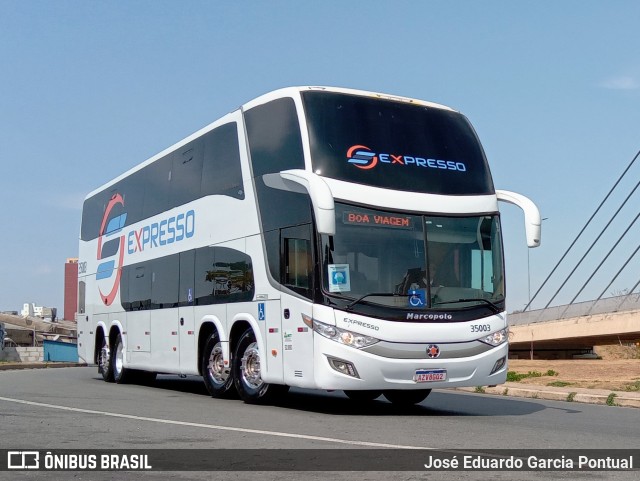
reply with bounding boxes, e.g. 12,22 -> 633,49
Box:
0,367 -> 640,480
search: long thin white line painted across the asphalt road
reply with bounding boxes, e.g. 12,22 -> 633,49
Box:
0,397 -> 436,450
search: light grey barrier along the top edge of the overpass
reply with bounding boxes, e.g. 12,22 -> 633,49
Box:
507,293 -> 640,326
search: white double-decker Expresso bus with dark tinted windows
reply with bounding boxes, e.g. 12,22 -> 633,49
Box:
77,87 -> 540,404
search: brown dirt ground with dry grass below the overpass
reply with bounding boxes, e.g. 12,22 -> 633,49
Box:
509,346 -> 640,391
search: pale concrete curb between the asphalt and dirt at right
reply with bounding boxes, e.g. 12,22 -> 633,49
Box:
455,382 -> 640,408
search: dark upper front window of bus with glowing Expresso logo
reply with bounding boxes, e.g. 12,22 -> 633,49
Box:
302,91 -> 494,195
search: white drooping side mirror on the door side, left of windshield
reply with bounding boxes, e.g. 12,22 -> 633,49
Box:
262,169 -> 336,235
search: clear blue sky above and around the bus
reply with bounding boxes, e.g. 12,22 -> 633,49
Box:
0,0 -> 640,311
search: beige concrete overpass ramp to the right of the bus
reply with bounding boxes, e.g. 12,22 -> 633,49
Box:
508,294 -> 640,359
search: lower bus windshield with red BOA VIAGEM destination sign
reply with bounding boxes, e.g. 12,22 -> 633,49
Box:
322,203 -> 504,313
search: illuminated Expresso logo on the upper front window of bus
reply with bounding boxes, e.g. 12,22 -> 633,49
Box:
347,145 -> 467,172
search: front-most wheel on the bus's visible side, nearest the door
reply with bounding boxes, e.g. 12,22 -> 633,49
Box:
231,329 -> 289,404
